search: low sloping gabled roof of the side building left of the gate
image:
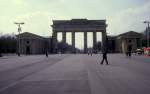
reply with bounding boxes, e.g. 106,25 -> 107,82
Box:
17,32 -> 44,39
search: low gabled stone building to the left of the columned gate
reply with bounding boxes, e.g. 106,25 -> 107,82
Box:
17,32 -> 50,54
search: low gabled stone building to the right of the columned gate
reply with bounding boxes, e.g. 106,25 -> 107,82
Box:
108,31 -> 143,53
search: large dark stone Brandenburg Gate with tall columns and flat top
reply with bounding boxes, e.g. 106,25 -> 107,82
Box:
52,19 -> 107,53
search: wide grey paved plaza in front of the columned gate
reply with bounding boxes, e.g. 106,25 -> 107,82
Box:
0,54 -> 150,94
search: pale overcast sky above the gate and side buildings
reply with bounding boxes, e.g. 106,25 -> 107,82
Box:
0,0 -> 150,48
